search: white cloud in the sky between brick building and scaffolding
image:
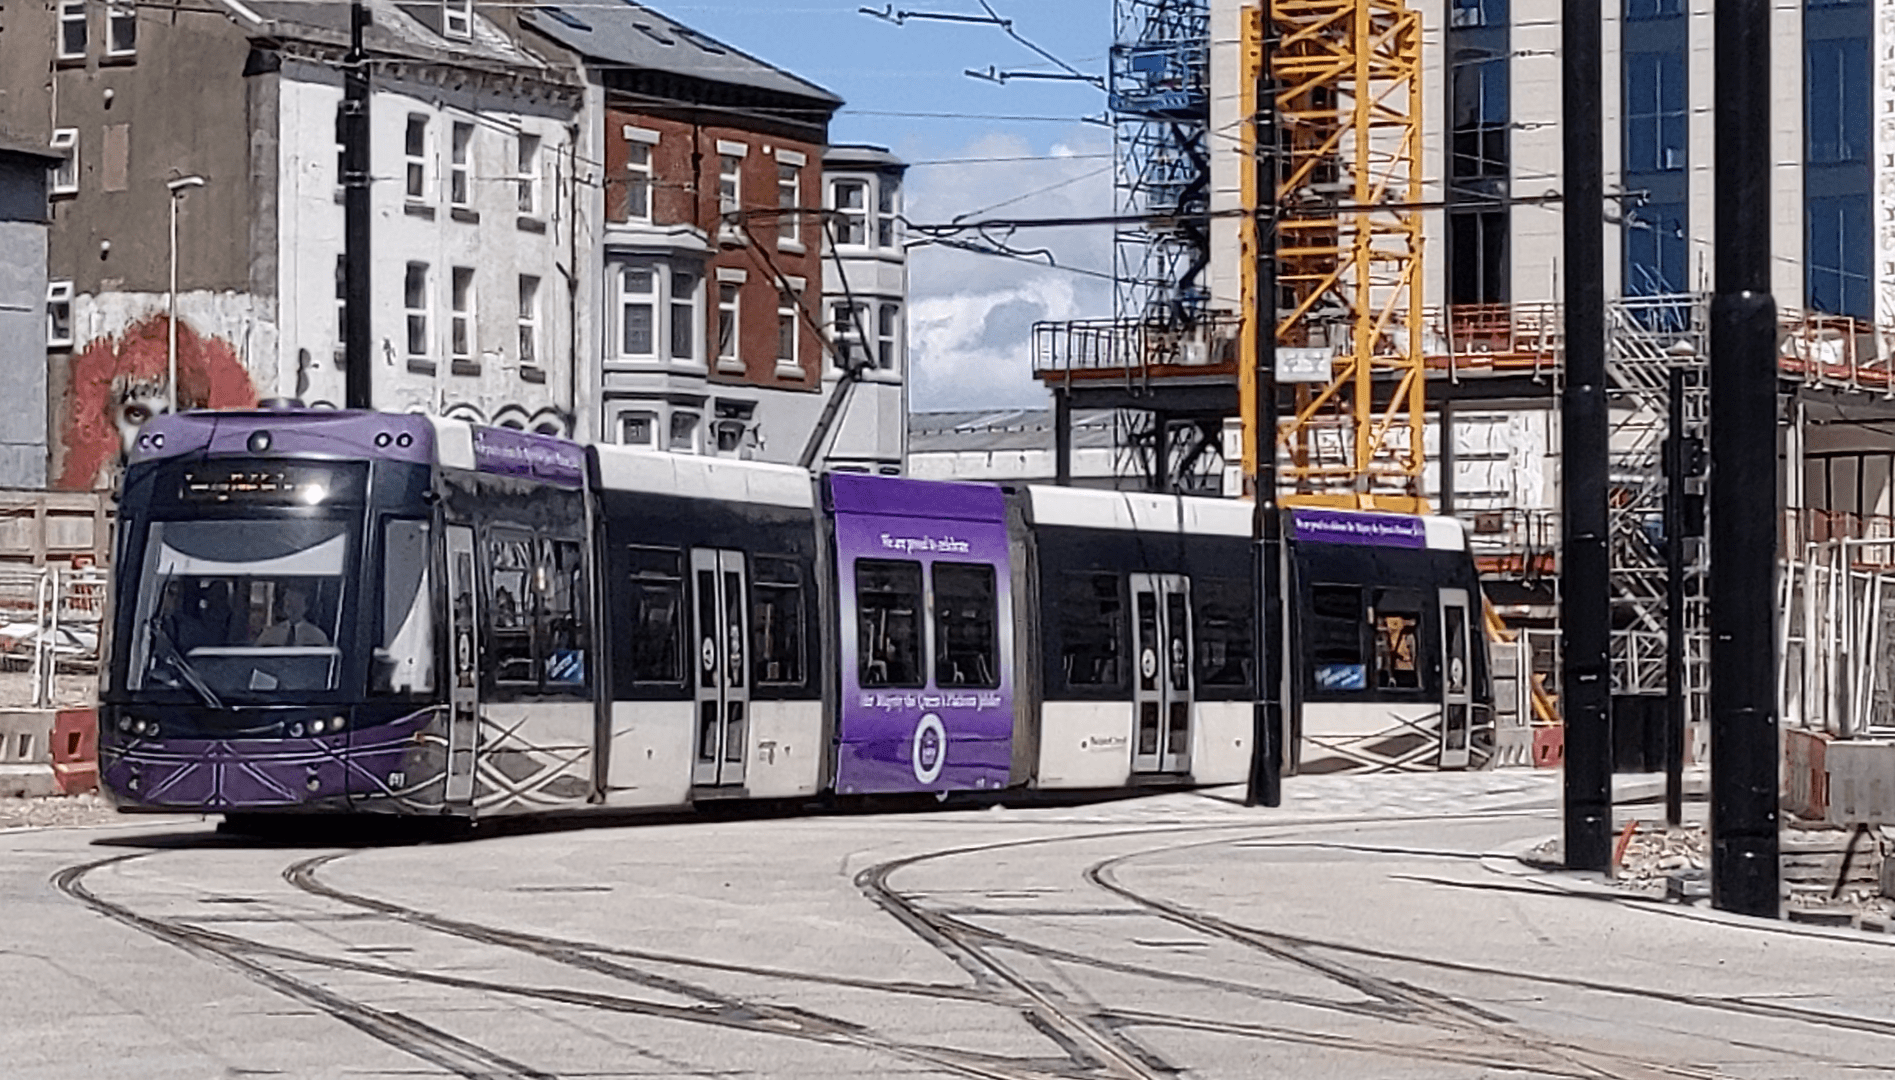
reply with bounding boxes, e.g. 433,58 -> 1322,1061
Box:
908,129 -> 1112,409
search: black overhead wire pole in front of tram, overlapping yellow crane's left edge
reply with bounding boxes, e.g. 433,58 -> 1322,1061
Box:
1239,4 -> 1285,807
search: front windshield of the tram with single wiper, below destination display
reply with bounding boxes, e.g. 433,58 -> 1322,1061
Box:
127,517 -> 352,707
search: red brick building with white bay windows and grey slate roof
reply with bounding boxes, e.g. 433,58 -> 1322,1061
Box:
521,6 -> 906,468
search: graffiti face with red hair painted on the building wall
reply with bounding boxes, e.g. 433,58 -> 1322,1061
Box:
57,315 -> 258,491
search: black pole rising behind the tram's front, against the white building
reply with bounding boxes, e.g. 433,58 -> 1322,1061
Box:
343,0 -> 375,409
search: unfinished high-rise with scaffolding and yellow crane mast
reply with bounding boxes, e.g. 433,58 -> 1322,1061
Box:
1035,0 -> 1895,760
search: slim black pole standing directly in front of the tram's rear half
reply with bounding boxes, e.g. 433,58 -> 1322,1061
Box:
1243,27 -> 1287,807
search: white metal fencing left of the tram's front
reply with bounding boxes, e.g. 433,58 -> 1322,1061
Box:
0,565 -> 110,709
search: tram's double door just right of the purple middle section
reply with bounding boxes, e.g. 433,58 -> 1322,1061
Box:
1131,574 -> 1194,773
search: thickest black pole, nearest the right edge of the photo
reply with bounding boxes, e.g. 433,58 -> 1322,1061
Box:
1711,0 -> 1779,919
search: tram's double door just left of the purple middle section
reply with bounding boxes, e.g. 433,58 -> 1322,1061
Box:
692,548 -> 750,784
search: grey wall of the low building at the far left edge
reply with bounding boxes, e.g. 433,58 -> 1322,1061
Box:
0,218 -> 47,487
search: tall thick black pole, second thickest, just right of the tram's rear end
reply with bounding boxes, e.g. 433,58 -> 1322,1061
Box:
1560,0 -> 1613,870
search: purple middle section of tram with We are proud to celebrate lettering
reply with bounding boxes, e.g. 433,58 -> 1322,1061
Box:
830,474 -> 1014,794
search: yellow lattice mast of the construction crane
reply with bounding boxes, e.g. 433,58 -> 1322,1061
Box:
1237,0 -> 1427,513
